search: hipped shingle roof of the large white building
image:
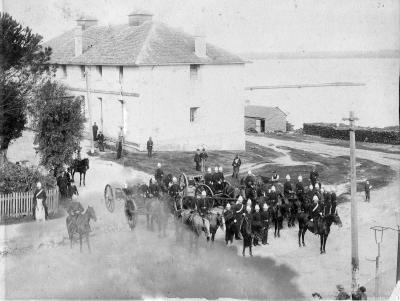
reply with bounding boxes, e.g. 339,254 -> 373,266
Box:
44,21 -> 245,66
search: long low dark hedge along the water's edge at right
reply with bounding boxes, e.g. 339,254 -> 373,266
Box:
303,123 -> 400,144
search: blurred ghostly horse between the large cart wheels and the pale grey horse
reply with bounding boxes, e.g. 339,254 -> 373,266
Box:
146,195 -> 169,237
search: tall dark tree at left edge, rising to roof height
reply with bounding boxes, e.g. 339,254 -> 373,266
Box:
0,13 -> 52,166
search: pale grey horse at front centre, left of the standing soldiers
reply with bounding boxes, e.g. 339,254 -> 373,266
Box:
176,209 -> 210,250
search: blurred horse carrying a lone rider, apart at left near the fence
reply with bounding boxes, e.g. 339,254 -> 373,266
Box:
65,206 -> 97,253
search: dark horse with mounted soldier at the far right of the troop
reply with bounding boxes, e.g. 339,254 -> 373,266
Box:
298,210 -> 342,254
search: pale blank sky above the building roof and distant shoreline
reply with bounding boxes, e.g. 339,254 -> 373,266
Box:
0,0 -> 400,53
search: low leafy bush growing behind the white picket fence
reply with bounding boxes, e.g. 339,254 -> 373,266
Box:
0,163 -> 56,194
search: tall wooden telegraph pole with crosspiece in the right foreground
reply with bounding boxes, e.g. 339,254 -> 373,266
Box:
343,111 -> 359,293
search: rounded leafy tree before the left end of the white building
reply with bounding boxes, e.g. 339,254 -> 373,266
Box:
32,80 -> 85,174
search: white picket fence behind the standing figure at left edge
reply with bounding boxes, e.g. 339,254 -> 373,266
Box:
0,188 -> 60,220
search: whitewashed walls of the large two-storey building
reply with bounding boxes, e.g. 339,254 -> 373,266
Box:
57,65 -> 245,150
